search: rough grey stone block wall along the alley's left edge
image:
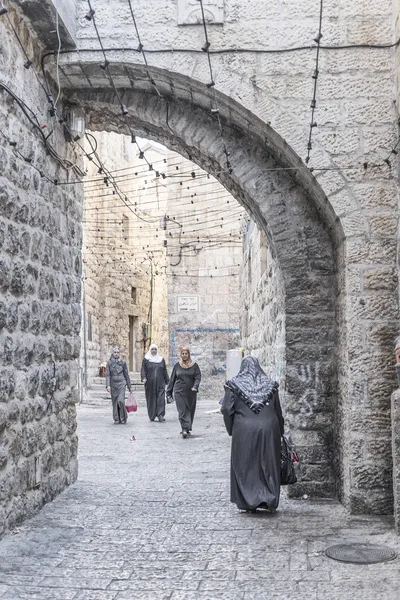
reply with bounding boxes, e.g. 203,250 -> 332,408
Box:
0,3 -> 82,535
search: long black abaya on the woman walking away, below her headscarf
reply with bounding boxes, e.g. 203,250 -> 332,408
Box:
221,389 -> 284,510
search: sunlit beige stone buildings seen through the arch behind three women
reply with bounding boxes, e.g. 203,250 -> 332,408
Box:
81,133 -> 242,395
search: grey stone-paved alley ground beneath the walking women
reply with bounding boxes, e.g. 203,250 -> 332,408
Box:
0,392 -> 400,600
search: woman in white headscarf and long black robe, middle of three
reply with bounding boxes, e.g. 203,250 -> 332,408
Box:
141,344 -> 169,423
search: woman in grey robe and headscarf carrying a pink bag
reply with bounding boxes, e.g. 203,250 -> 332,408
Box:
106,346 -> 131,425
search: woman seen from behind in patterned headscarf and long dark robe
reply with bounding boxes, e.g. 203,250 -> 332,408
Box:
221,356 -> 284,512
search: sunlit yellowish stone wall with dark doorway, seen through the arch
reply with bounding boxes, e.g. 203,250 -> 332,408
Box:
81,133 -> 169,385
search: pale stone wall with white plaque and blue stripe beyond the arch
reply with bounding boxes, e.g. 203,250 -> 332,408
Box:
167,153 -> 241,401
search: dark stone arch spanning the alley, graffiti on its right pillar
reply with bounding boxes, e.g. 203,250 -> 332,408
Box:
62,62 -> 343,496
